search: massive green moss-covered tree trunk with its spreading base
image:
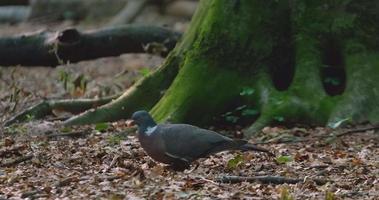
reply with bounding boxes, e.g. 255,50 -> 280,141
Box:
14,0 -> 379,136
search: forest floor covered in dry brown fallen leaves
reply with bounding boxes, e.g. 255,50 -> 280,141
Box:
0,8 -> 379,200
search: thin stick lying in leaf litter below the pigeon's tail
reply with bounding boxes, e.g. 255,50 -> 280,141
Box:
216,176 -> 328,185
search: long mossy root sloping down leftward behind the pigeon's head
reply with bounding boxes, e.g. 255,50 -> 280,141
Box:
64,53 -> 180,126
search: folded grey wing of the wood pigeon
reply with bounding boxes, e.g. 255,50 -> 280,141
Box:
159,124 -> 239,162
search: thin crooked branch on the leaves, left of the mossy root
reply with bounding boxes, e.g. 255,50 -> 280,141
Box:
5,94 -> 120,126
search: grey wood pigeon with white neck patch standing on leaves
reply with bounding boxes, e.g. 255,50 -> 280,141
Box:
129,110 -> 272,170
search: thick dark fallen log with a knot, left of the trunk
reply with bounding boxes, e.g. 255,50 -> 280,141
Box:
0,25 -> 181,67
